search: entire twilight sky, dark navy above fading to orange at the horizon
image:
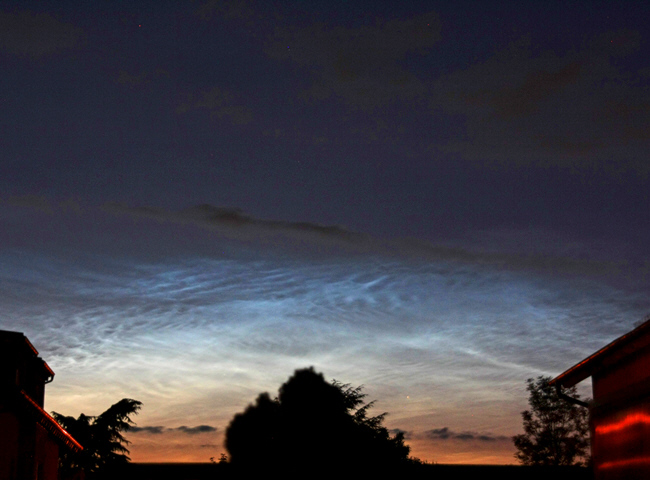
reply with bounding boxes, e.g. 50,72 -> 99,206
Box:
0,0 -> 650,463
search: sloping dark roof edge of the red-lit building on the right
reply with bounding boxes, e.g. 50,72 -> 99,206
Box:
549,318 -> 650,388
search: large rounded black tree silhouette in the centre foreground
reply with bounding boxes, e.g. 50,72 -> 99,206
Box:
226,367 -> 410,472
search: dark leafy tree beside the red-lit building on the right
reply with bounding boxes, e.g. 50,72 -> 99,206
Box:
512,376 -> 589,465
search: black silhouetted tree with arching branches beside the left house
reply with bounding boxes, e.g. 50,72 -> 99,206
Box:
52,398 -> 142,479
